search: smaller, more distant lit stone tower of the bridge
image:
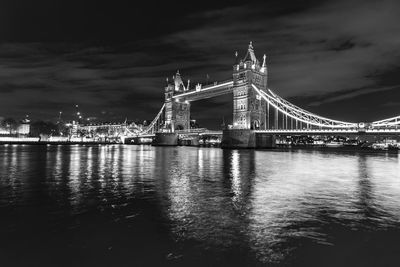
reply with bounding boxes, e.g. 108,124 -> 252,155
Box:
164,70 -> 190,132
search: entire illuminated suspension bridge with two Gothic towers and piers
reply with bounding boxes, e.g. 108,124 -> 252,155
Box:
130,42 -> 400,147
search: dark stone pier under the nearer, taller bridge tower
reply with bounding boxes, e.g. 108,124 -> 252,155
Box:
221,129 -> 276,148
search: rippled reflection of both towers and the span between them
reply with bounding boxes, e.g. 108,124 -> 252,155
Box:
159,148 -> 254,248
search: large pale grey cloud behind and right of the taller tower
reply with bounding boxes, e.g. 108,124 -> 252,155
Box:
162,1 -> 400,96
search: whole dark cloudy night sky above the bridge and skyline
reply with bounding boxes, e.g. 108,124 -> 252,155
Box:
0,0 -> 400,128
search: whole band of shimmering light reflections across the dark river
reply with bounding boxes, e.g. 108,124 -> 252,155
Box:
0,145 -> 400,262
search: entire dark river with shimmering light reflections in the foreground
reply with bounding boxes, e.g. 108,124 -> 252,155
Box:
0,145 -> 400,266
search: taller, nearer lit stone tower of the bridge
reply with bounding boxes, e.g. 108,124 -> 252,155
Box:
233,42 -> 268,130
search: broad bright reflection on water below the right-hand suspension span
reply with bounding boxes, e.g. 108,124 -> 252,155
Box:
249,151 -> 400,262
